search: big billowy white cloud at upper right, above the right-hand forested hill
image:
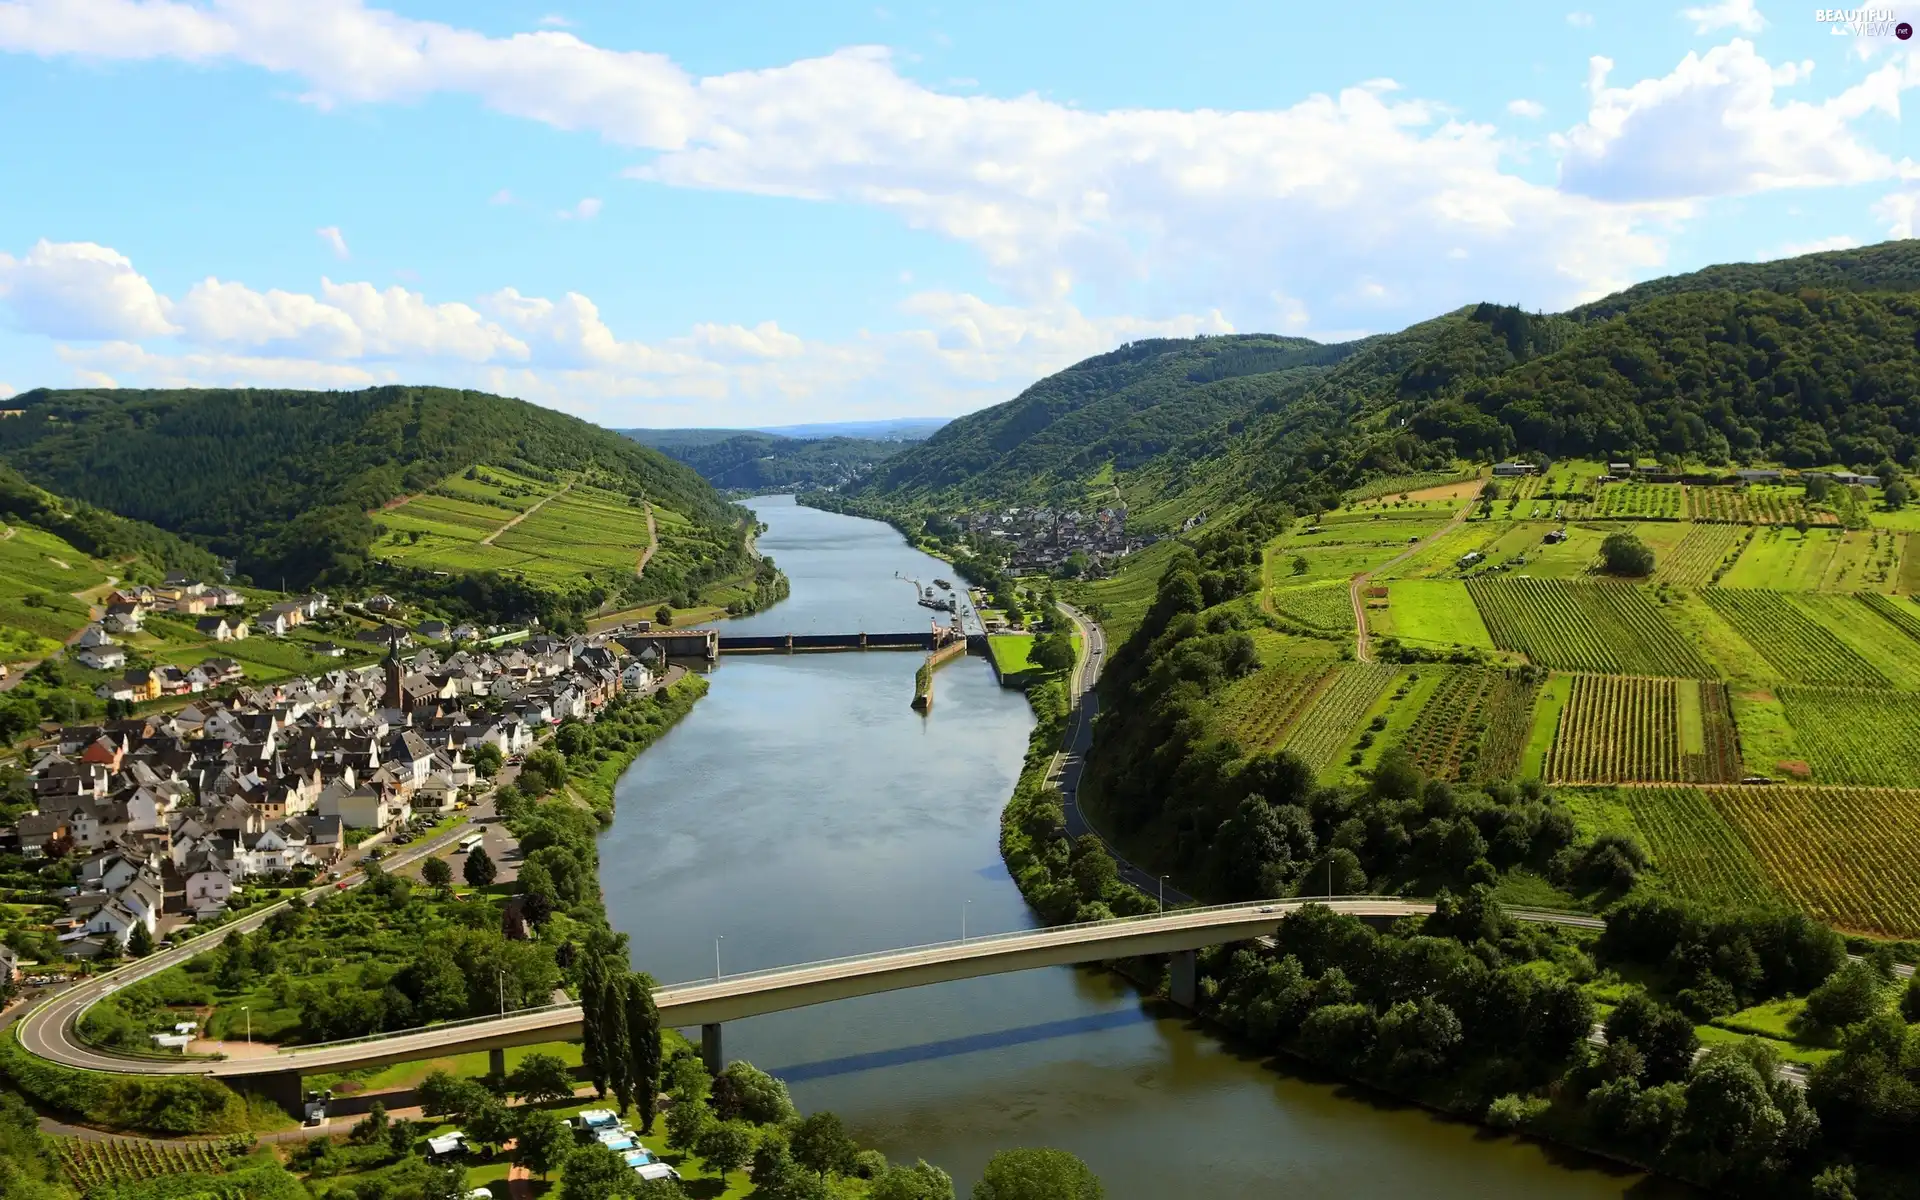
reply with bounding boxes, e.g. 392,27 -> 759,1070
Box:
1555,38 -> 1908,202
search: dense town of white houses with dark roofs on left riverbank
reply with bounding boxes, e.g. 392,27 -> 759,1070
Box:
0,606 -> 664,963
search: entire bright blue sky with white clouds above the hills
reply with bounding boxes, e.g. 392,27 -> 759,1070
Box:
0,0 -> 1920,426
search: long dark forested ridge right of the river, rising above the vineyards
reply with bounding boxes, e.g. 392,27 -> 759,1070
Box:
849,240 -> 1920,530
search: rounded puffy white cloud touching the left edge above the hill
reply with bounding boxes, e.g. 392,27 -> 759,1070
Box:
0,238 -> 173,340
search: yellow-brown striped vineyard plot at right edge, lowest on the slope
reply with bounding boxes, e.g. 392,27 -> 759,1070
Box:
1707,787 -> 1920,937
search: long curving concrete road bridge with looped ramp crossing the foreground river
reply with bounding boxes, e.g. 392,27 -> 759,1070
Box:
17,897 -> 1599,1112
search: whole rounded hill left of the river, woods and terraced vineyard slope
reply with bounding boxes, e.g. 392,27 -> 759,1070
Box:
0,388 -> 755,620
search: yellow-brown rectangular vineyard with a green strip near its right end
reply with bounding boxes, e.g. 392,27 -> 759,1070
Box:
1546,676 -> 1740,783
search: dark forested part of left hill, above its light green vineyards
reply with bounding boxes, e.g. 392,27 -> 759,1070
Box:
0,386 -> 739,588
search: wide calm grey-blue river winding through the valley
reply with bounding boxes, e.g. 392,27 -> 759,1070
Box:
601,497 -> 1688,1200
